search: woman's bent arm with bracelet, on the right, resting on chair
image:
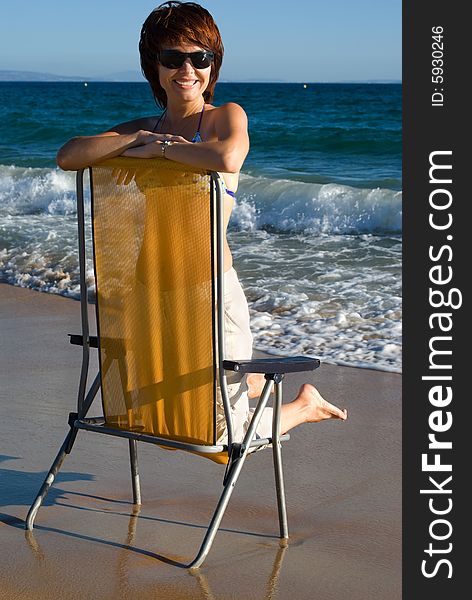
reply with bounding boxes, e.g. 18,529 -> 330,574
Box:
122,102 -> 249,173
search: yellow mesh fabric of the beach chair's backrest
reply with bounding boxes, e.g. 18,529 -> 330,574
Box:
92,157 -> 216,445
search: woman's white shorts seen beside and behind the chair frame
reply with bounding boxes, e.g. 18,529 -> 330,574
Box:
216,268 -> 272,444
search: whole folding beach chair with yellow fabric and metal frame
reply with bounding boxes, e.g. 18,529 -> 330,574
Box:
26,157 -> 319,568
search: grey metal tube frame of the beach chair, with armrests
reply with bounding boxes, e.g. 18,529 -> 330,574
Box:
25,163 -> 319,569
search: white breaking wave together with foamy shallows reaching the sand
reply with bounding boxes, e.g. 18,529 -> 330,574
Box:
0,166 -> 401,371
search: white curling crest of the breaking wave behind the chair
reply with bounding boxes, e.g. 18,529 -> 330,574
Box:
0,166 -> 402,235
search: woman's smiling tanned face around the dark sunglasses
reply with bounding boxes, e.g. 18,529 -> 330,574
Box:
158,44 -> 211,102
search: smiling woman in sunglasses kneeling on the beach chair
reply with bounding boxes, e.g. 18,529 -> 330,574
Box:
57,2 -> 347,441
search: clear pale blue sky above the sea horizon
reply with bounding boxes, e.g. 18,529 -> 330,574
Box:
0,0 -> 401,81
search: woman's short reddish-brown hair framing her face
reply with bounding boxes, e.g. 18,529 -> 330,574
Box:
139,0 -> 224,108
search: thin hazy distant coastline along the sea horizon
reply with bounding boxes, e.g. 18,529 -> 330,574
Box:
0,70 -> 401,84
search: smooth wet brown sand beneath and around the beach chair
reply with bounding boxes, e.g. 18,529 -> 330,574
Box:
0,284 -> 401,600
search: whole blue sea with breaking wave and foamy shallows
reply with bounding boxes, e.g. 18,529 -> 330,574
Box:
0,82 -> 402,372
